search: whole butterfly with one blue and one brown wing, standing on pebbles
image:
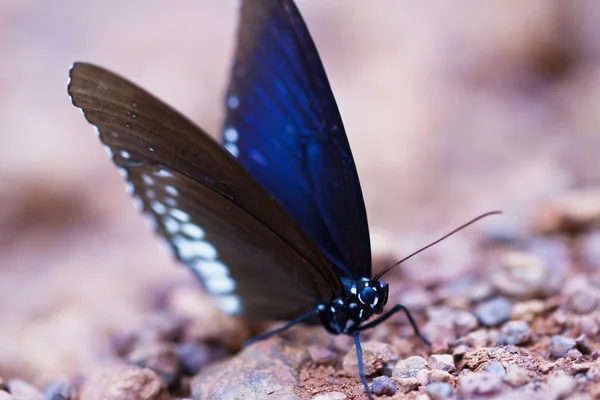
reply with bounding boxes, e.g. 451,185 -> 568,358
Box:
68,0 -> 500,398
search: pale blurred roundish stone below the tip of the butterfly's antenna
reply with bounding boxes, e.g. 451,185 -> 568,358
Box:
492,251 -> 553,300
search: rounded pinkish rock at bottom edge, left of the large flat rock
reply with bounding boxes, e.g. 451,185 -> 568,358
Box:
80,365 -> 171,400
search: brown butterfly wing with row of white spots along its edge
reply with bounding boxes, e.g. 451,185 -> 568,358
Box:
68,63 -> 341,319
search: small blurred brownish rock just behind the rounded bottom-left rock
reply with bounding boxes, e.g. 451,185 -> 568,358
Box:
127,342 -> 181,387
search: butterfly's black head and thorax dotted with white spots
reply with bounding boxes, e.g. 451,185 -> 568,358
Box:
318,278 -> 388,335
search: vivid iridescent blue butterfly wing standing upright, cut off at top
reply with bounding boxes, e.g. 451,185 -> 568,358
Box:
223,0 -> 371,278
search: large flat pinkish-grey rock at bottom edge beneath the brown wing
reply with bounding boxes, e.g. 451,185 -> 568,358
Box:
190,337 -> 308,399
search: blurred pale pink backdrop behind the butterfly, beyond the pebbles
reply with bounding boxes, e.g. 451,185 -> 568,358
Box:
0,0 -> 600,384
